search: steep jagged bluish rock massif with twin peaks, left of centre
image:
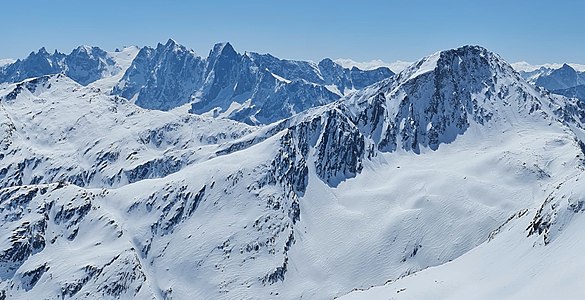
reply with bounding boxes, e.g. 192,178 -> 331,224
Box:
113,40 -> 393,124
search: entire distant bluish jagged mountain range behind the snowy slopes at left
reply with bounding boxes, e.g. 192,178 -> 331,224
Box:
0,39 -> 394,125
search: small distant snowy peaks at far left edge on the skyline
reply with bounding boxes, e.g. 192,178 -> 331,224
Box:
0,46 -> 136,85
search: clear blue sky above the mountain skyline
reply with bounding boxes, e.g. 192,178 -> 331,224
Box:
0,0 -> 585,64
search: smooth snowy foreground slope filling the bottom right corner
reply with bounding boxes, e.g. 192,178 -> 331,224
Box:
340,174 -> 585,300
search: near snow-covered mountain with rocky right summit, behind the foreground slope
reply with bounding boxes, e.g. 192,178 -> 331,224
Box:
0,43 -> 585,299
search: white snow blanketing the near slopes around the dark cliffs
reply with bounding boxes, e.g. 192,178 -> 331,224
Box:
0,45 -> 585,299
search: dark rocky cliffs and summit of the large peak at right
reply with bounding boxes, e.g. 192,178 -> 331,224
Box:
272,46 -> 550,191
